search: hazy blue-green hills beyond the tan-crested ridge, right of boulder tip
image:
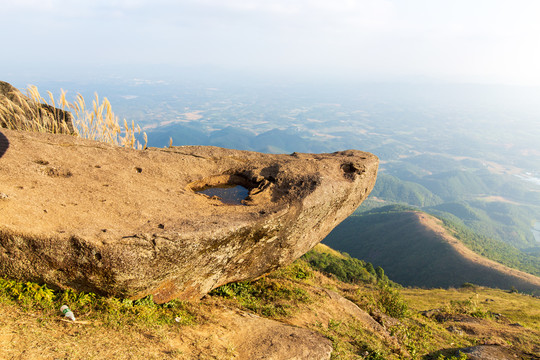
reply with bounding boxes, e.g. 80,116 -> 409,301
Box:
382,158 -> 540,253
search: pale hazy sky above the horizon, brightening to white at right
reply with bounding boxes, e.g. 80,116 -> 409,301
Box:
0,0 -> 540,86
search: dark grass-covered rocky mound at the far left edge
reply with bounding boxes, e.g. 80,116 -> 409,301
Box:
0,81 -> 74,134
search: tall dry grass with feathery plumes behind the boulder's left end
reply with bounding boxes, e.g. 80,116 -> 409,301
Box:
0,86 -> 148,150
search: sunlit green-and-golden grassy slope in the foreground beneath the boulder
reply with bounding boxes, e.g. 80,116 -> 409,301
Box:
0,249 -> 540,359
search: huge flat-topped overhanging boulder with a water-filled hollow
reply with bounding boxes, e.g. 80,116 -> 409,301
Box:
0,130 -> 378,302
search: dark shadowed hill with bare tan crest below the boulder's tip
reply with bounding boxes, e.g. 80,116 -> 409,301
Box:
324,210 -> 540,292
